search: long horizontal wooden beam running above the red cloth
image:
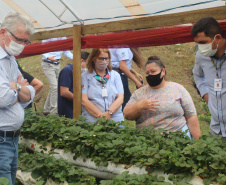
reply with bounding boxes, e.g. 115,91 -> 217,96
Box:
31,6 -> 226,40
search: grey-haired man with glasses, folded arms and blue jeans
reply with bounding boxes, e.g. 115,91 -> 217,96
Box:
0,13 -> 35,184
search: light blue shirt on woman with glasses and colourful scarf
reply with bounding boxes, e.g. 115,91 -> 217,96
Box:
82,70 -> 124,122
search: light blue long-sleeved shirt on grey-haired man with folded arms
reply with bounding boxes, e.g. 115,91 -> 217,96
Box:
0,47 -> 35,131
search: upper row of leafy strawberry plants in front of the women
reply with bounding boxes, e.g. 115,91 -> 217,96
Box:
22,113 -> 226,184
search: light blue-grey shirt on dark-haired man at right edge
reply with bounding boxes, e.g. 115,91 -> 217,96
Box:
193,52 -> 226,137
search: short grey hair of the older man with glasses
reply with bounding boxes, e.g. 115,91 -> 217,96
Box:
1,13 -> 34,35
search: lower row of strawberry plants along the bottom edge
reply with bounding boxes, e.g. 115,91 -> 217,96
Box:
17,145 -> 192,185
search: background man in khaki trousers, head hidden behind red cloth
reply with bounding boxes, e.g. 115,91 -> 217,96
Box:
42,37 -> 73,115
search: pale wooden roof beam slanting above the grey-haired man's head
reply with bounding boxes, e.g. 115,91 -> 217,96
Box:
3,0 -> 45,31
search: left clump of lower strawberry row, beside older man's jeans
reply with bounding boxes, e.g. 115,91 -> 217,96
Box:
19,147 -> 96,185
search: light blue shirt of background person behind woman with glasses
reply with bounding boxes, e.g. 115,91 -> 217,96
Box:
109,48 -> 133,70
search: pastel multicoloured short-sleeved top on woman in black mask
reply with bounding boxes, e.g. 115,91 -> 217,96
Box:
126,82 -> 196,131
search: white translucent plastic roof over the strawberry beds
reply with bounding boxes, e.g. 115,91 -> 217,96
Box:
0,0 -> 225,31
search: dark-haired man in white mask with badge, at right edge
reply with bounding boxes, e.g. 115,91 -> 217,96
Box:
191,17 -> 226,141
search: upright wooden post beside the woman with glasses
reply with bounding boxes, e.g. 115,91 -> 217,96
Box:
73,25 -> 82,119
